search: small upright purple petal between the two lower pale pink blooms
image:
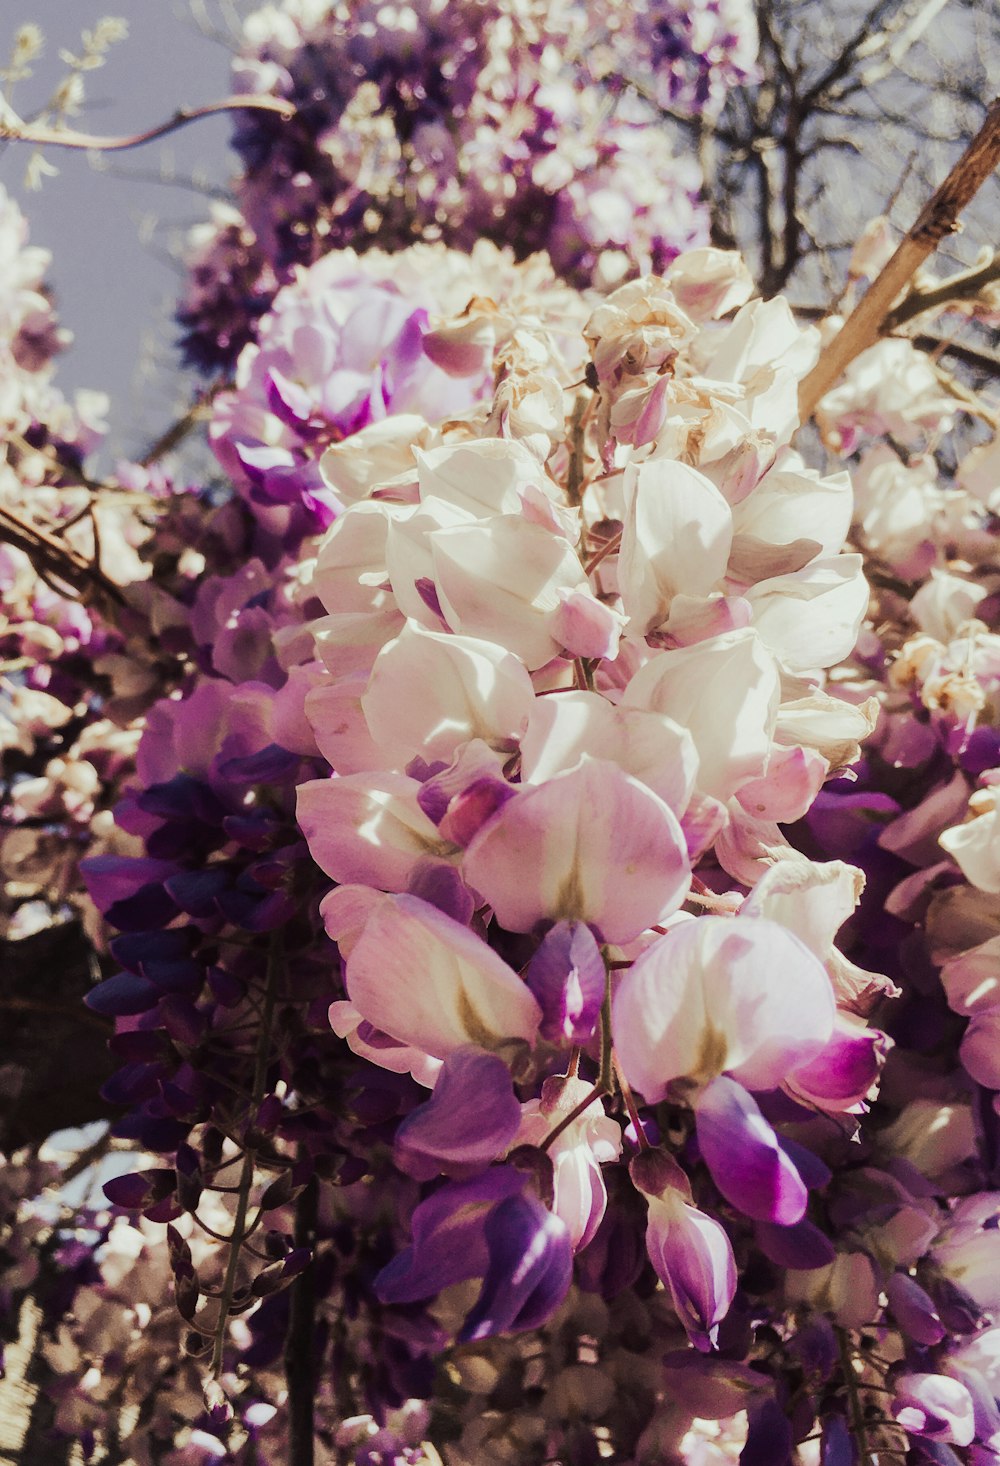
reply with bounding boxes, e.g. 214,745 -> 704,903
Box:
525,921 -> 604,1044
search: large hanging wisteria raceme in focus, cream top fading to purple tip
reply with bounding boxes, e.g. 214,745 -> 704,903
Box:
284,251 -> 884,1372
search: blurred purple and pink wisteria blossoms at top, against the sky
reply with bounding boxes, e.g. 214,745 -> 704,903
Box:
180,0 -> 757,367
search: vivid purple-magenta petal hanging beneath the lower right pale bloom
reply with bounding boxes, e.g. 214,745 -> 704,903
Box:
695,1075 -> 808,1227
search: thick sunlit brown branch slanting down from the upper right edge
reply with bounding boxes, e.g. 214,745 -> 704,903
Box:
799,100 -> 1000,422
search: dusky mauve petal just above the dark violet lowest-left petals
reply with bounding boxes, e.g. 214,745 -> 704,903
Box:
396,1048 -> 521,1182
